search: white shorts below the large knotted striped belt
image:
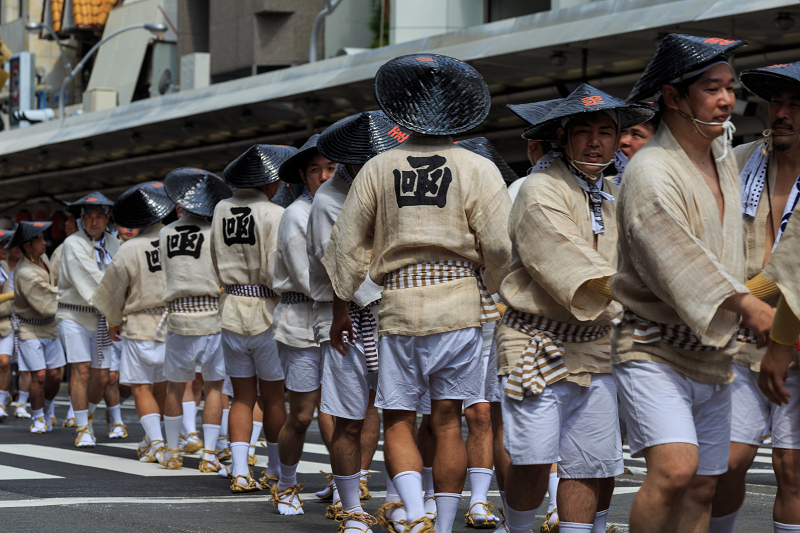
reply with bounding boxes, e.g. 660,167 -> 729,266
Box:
503,374 -> 625,479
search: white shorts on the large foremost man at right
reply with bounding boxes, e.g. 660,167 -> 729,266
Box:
612,361 -> 732,476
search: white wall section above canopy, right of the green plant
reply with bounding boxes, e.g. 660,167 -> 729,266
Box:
389,0 -> 485,44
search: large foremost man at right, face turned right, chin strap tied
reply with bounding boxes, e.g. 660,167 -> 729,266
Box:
611,34 -> 773,532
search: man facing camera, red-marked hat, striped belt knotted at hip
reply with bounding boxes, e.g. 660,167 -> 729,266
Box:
496,84 -> 653,533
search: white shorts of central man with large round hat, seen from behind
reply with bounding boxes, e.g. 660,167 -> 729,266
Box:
375,328 -> 484,411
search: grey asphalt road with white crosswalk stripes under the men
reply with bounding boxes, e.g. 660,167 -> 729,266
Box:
0,384 -> 775,533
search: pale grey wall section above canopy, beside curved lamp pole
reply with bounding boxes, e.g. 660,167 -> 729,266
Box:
324,0 -> 374,58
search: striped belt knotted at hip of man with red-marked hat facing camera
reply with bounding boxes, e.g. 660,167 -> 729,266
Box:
502,307 -> 611,400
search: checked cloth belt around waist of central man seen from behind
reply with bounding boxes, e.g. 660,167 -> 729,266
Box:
383,261 -> 500,322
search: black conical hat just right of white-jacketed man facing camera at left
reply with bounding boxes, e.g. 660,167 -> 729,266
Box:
111,181 -> 175,229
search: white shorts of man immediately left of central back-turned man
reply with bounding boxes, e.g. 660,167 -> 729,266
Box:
319,339 -> 383,420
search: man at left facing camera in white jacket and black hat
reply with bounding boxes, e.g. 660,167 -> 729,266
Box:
56,192 -> 119,448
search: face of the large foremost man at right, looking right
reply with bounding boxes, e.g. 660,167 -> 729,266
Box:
678,64 -> 736,136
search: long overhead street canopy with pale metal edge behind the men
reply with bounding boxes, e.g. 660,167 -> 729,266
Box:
0,0 -> 800,209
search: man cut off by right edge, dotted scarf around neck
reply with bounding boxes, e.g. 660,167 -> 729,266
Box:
711,63 -> 800,533
